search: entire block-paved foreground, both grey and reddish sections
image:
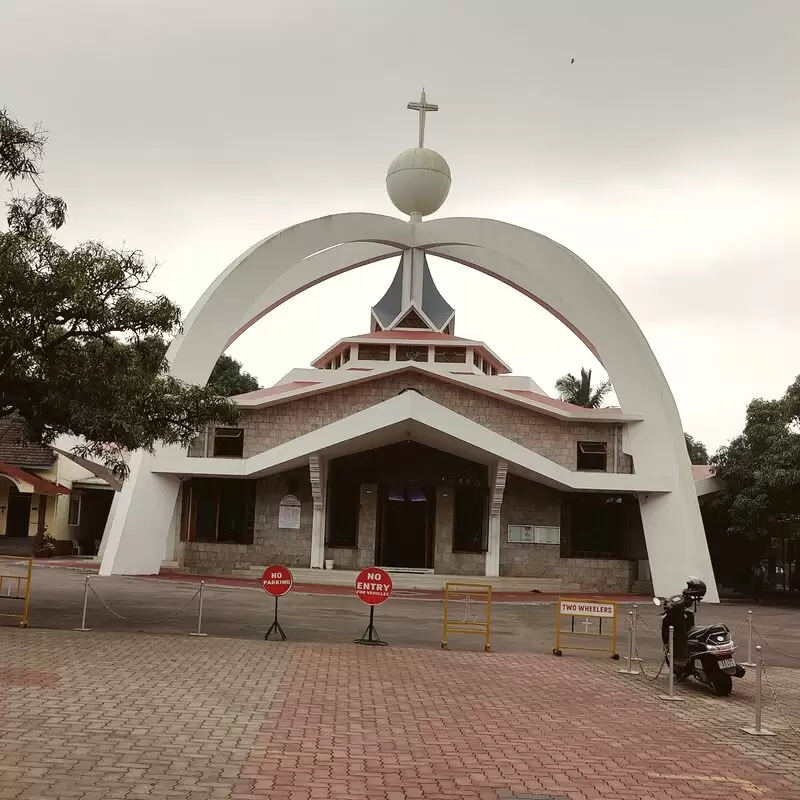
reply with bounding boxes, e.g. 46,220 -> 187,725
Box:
0,628 -> 800,800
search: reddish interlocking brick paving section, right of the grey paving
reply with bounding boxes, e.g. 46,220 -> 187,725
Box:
233,646 -> 800,800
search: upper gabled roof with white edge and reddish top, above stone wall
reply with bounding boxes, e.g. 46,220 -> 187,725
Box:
235,361 -> 642,423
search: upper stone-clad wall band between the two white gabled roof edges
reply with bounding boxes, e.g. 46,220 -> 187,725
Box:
191,374 -> 628,472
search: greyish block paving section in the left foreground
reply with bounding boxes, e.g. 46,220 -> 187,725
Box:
0,628 -> 288,800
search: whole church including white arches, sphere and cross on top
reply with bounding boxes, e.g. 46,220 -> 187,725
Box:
100,92 -> 716,601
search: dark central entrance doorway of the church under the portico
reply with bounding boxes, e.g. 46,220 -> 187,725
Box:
376,486 -> 436,569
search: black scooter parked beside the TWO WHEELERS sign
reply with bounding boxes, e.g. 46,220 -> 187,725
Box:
653,578 -> 745,697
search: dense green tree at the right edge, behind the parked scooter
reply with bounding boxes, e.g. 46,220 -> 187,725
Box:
712,376 -> 800,538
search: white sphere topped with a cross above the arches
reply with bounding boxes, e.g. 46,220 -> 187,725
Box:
386,89 -> 451,217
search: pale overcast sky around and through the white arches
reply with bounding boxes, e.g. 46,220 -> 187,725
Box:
0,0 -> 800,450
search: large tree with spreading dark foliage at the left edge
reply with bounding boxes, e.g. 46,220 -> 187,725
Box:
0,110 -> 250,474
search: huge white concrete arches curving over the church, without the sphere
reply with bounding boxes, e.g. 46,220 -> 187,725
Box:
101,214 -> 716,600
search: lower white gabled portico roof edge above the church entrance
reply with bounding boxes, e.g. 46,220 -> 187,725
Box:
153,391 -> 674,493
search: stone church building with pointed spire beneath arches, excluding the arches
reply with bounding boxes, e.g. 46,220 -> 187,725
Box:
176,250 -> 647,591
